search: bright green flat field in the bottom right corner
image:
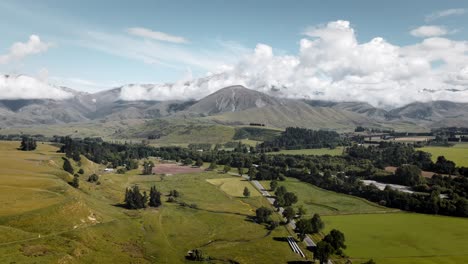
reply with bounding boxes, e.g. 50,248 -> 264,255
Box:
323,213 -> 468,264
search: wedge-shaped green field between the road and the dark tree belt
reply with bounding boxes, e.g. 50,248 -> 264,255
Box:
262,178 -> 395,217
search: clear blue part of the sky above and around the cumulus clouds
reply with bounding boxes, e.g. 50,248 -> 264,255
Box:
0,0 -> 468,106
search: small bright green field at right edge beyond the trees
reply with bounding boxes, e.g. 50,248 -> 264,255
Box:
420,143 -> 468,167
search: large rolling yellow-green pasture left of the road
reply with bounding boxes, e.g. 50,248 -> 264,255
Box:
0,142 -> 304,263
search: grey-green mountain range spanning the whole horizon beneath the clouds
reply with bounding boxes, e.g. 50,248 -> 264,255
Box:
0,75 -> 468,133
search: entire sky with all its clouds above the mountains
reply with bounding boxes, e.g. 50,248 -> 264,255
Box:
0,0 -> 468,107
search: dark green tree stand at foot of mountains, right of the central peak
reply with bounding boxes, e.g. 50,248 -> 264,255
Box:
258,127 -> 347,152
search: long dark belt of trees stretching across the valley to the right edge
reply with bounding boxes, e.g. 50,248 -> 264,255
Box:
59,139 -> 468,216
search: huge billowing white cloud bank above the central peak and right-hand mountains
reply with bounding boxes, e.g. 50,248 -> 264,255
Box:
121,20 -> 468,108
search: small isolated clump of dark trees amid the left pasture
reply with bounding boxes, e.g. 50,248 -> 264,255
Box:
124,185 -> 161,209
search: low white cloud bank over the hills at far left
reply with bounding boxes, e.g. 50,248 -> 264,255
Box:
0,75 -> 72,100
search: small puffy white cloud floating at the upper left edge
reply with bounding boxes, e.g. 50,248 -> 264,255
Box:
0,35 -> 51,64
